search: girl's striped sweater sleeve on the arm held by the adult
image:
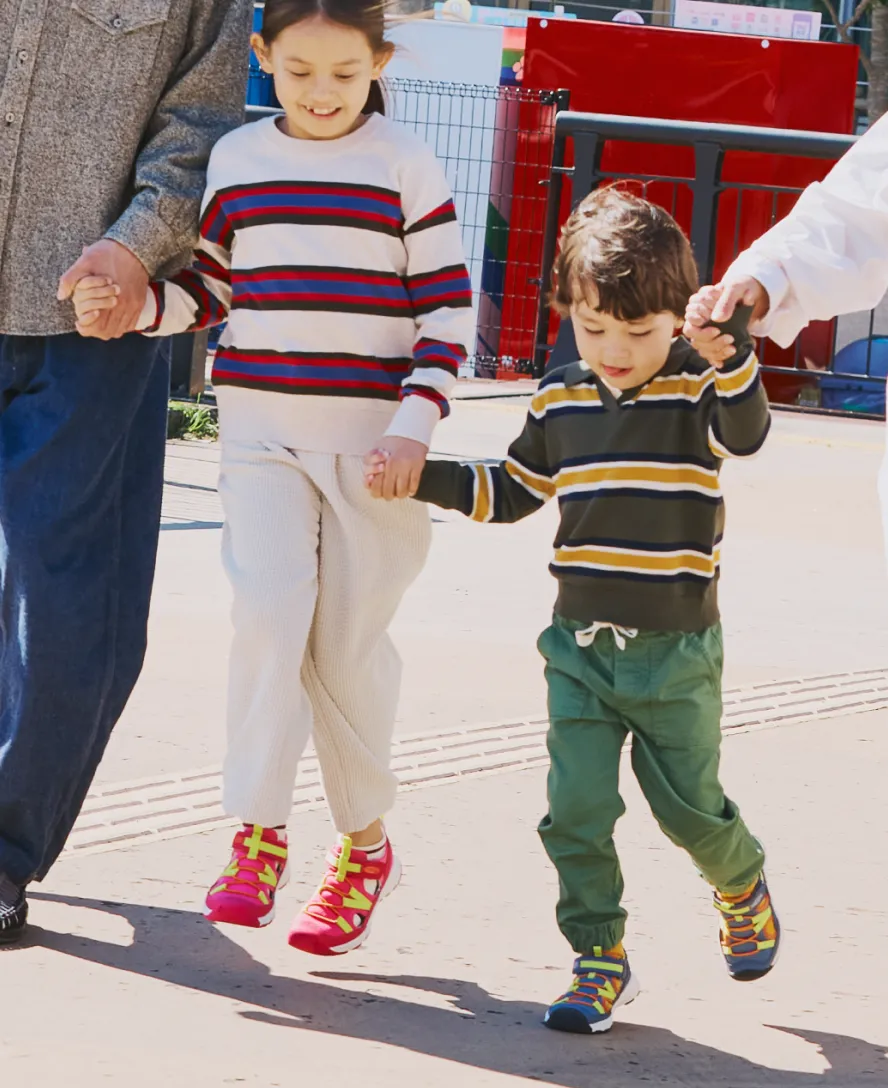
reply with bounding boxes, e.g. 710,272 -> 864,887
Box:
138,176 -> 232,336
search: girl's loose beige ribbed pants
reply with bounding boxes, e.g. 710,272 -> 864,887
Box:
220,442 -> 431,833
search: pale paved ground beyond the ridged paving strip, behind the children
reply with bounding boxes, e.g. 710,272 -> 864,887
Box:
100,401 -> 888,782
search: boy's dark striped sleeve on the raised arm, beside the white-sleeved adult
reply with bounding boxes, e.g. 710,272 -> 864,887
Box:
708,351 -> 770,458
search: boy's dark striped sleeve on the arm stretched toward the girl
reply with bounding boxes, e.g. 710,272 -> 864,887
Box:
416,404 -> 555,523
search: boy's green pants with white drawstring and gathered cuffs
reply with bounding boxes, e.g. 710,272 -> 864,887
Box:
540,616 -> 764,955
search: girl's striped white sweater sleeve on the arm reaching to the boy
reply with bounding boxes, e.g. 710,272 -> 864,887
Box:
387,147 -> 474,446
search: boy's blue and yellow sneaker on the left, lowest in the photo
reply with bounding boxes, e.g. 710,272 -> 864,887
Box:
543,944 -> 640,1035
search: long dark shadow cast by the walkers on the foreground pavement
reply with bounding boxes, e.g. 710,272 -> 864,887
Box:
13,892 -> 888,1088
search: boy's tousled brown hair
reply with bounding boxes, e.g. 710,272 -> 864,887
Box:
551,187 -> 699,321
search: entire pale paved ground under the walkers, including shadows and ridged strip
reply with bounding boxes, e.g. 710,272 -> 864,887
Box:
0,401 -> 888,1088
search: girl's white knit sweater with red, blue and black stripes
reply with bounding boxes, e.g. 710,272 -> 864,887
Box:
139,114 -> 474,454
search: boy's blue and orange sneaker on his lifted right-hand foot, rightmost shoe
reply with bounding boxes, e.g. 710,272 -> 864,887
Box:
714,874 -> 780,982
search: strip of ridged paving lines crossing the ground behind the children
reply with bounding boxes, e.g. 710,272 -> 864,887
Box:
62,669 -> 888,857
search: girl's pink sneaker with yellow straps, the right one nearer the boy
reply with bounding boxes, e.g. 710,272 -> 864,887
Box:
289,837 -> 400,955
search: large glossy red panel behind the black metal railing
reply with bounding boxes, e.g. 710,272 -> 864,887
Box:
501,20 -> 858,399
